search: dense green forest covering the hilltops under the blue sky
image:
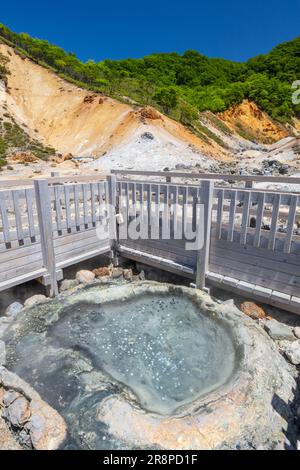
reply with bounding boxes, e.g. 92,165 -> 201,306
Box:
0,25 -> 300,125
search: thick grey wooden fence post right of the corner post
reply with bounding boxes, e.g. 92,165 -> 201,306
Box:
196,181 -> 214,289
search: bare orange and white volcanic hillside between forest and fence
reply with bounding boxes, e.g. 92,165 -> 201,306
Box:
0,27 -> 300,176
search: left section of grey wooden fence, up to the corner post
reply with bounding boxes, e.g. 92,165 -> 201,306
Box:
0,178 -> 110,296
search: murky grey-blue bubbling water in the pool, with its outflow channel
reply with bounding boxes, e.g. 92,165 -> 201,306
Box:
4,295 -> 235,448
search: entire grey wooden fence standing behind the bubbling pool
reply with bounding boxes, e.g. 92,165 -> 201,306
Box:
0,172 -> 300,313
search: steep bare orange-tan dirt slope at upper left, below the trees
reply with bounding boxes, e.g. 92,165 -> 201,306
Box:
0,45 -> 228,159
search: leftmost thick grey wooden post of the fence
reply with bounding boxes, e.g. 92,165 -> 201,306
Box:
34,180 -> 58,297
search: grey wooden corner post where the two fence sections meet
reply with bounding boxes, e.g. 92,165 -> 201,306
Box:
107,175 -> 118,265
